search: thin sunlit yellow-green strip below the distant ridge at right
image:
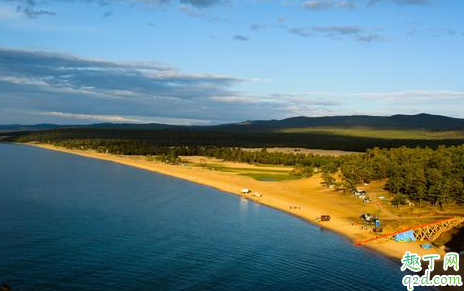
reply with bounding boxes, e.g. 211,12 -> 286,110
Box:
281,127 -> 464,140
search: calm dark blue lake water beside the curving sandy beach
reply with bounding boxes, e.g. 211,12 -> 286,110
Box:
0,143 -> 432,291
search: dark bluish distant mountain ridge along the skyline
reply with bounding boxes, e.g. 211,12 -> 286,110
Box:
0,113 -> 464,132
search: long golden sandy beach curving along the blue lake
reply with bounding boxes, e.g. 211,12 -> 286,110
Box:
24,144 -> 450,262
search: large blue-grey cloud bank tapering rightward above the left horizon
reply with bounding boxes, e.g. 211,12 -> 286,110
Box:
0,48 -> 294,123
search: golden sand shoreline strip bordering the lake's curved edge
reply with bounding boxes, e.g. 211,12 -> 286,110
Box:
18,143 -> 444,263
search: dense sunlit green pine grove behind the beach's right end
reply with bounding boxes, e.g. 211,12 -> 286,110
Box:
341,146 -> 464,206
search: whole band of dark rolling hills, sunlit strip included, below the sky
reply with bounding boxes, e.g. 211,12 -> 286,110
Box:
0,114 -> 464,151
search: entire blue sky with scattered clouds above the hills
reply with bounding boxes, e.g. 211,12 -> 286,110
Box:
0,0 -> 464,125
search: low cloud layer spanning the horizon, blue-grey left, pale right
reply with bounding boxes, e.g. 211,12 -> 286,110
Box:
0,47 -> 464,125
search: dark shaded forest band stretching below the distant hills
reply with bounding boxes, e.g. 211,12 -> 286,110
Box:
4,128 -> 463,152
